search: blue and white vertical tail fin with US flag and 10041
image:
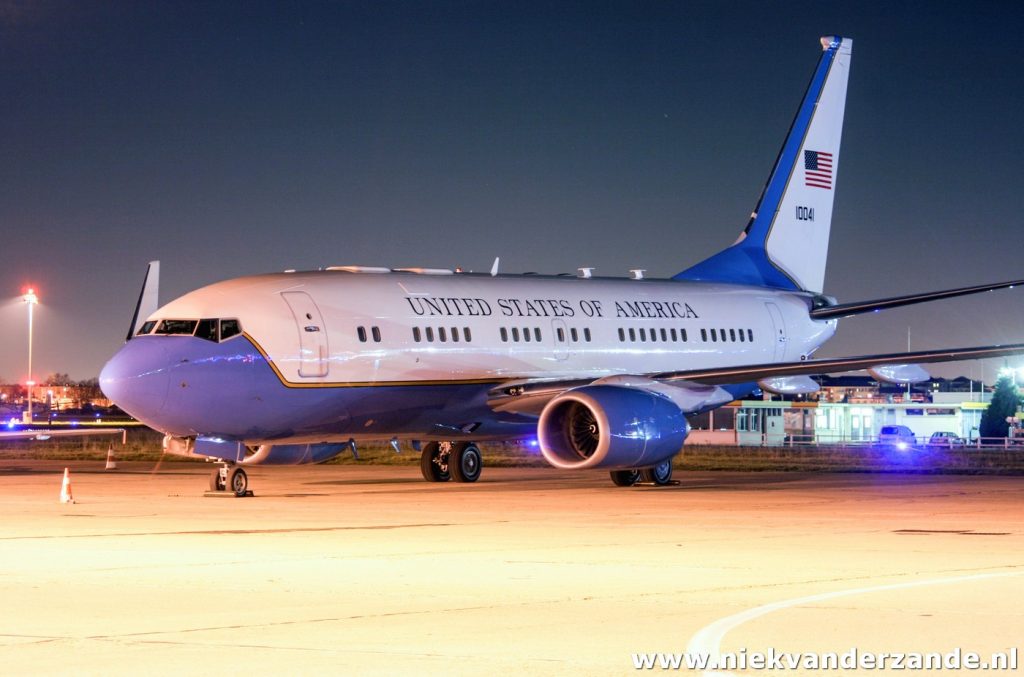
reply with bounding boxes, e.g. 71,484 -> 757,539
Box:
675,36 -> 853,292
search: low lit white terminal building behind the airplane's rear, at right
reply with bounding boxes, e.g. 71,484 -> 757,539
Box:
687,376 -> 992,447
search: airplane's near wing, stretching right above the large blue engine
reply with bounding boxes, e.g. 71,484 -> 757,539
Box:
487,343 -> 1024,415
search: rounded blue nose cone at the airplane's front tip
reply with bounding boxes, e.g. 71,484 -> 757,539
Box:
99,337 -> 170,424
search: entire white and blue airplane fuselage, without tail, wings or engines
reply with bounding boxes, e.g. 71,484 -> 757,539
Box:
104,268 -> 836,445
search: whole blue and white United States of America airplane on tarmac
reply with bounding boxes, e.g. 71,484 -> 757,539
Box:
100,36 -> 1024,496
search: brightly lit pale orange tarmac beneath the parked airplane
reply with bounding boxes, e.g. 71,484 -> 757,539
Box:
0,460 -> 1024,675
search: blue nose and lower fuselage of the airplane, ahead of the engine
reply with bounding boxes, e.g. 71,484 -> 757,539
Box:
100,336 -> 537,443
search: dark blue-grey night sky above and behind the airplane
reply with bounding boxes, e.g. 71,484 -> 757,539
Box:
0,0 -> 1024,382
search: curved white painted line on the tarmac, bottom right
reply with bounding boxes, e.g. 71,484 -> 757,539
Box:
686,572 -> 1024,677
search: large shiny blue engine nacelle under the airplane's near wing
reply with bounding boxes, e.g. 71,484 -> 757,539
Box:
538,385 -> 689,470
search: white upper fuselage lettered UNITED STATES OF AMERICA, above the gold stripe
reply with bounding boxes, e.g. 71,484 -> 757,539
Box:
150,270 -> 836,387
